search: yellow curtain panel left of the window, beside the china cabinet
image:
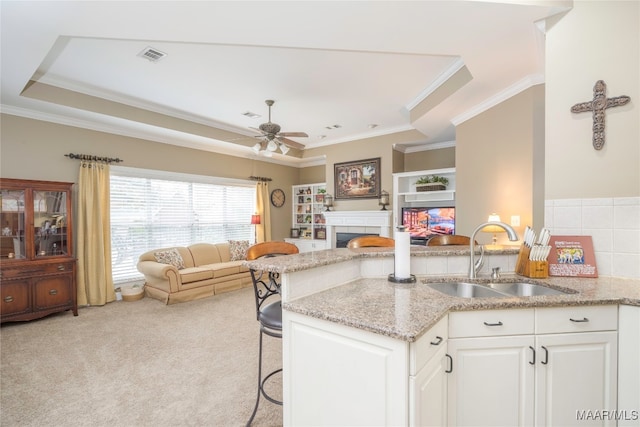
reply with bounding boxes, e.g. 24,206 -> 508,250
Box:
76,161 -> 116,305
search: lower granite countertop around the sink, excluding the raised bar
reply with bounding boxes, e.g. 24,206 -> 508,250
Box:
282,275 -> 640,342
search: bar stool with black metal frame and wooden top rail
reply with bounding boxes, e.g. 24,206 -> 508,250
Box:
247,242 -> 299,426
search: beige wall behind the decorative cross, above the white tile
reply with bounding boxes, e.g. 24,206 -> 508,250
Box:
545,1 -> 640,199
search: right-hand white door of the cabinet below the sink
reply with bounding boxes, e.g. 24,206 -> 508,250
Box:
536,332 -> 618,426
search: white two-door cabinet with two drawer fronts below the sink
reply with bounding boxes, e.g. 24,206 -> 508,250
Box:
448,306 -> 617,426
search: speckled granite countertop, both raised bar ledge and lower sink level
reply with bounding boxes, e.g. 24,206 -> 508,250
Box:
243,246 -> 640,342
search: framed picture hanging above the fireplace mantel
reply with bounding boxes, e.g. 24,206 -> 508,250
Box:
333,157 -> 380,199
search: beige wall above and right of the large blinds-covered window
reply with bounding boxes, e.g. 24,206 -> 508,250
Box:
0,114 -> 299,240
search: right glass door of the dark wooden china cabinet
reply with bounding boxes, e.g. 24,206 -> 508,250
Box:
33,190 -> 70,257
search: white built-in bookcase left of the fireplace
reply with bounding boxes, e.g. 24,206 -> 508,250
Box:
286,183 -> 326,252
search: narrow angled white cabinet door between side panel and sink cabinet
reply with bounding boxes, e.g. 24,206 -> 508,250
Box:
409,346 -> 450,427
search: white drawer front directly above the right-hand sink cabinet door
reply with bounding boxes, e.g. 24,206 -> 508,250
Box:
536,305 -> 618,334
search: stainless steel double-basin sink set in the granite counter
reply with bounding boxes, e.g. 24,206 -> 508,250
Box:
427,282 -> 568,298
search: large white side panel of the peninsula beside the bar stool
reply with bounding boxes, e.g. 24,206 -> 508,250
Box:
283,311 -> 409,426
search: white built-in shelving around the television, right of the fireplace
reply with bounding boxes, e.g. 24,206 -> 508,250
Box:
391,168 -> 456,231
